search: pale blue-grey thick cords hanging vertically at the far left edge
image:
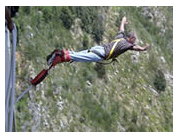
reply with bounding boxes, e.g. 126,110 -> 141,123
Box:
5,23 -> 17,132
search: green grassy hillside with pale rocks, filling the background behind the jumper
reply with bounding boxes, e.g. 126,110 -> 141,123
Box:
14,7 -> 173,132
